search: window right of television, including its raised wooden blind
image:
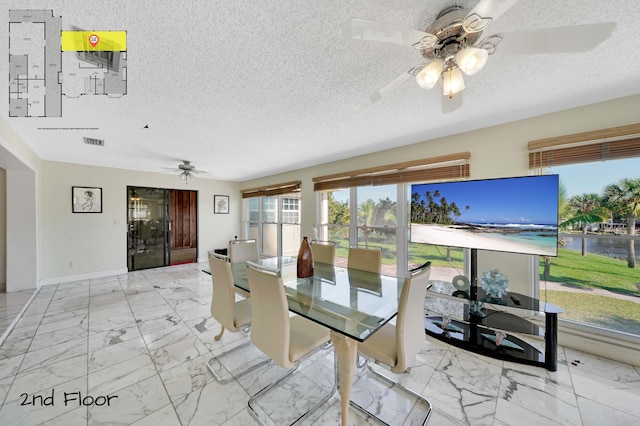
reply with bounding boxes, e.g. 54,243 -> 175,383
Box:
529,124 -> 640,336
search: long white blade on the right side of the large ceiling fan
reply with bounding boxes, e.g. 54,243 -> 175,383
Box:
495,22 -> 616,55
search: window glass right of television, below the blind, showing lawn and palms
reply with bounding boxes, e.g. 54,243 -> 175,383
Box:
540,158 -> 640,335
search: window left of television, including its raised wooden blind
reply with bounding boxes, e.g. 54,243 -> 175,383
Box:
313,152 -> 470,276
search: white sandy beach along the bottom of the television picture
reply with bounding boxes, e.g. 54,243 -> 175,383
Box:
411,223 -> 555,256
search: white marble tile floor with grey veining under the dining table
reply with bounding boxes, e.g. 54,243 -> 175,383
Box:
0,264 -> 640,426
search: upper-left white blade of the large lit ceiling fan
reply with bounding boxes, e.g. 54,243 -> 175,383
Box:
340,18 -> 439,49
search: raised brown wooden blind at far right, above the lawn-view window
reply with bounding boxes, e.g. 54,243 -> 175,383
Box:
529,124 -> 640,169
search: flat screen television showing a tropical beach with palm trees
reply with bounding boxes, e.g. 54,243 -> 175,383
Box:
410,175 -> 559,256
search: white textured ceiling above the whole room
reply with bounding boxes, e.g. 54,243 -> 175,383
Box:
0,0 -> 640,181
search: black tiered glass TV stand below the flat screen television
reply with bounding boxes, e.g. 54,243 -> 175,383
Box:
424,249 -> 563,371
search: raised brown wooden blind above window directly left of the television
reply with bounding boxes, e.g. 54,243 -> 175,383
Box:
313,152 -> 471,191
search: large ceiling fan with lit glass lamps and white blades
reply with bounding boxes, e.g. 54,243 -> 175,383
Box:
340,0 -> 616,113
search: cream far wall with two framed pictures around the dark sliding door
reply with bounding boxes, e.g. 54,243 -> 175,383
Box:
38,161 -> 241,284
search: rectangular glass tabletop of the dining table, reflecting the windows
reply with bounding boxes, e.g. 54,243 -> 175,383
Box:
231,257 -> 404,341
